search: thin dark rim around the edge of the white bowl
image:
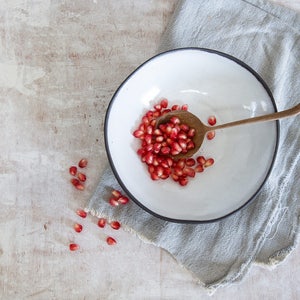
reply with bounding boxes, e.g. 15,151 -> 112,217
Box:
104,47 -> 280,224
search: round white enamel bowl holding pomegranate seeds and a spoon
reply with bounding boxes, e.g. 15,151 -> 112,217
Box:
105,48 -> 279,222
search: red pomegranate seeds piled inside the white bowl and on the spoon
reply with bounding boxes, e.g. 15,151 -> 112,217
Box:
131,99 -> 216,185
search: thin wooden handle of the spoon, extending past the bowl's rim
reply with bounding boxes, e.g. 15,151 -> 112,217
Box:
209,103 -> 300,130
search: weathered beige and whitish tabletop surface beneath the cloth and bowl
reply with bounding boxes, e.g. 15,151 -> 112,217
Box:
0,0 -> 300,300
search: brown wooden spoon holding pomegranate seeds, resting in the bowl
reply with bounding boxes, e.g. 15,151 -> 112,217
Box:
156,104 -> 300,158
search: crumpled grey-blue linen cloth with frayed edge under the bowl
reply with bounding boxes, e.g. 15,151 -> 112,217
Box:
86,0 -> 300,291
